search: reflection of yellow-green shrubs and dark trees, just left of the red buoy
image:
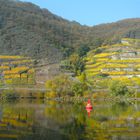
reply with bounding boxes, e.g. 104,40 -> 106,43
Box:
45,102 -> 86,140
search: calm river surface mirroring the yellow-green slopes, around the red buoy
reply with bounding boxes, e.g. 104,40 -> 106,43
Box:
0,100 -> 140,140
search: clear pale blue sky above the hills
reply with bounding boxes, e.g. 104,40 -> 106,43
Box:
22,0 -> 140,26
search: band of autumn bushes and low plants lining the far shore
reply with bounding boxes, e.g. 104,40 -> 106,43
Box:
0,75 -> 140,102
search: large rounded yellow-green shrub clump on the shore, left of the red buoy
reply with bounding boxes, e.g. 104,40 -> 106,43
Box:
46,75 -> 87,97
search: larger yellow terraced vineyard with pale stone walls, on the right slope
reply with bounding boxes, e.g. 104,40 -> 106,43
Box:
85,38 -> 140,86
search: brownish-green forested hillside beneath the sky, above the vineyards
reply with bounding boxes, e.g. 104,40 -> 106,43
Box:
0,0 -> 140,63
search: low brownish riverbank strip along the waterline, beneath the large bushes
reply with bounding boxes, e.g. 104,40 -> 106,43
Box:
0,90 -> 140,103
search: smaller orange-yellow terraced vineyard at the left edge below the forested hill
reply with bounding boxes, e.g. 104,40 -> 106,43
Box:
0,56 -> 35,85
